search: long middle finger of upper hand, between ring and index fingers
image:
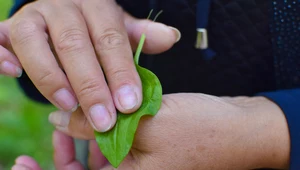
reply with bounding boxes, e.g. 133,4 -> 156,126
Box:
44,0 -> 116,132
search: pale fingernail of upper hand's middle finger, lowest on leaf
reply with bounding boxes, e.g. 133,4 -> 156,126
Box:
90,104 -> 112,132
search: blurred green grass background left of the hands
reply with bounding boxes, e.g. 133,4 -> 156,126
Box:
0,0 -> 55,170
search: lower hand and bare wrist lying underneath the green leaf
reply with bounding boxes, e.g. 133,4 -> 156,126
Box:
12,94 -> 289,170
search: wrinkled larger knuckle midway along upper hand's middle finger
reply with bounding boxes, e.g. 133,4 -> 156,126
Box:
57,28 -> 86,53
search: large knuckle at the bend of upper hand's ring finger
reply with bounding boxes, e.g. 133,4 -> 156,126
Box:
10,18 -> 38,44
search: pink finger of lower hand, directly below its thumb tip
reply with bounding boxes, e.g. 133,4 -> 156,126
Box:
53,131 -> 84,170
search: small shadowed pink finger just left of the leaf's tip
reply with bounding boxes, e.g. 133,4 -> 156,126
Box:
88,140 -> 108,170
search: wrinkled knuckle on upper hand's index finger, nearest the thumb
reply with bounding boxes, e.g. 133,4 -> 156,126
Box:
94,28 -> 126,50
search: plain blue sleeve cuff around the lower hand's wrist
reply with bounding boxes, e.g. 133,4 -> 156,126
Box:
259,89 -> 300,170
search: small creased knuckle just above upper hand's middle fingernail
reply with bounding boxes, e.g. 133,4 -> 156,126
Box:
78,78 -> 102,98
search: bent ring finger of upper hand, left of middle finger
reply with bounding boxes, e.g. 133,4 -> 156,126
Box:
10,7 -> 77,110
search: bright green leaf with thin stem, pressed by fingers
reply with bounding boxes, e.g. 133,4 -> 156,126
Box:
95,34 -> 162,168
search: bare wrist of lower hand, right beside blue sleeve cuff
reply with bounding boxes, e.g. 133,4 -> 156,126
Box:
239,97 -> 290,169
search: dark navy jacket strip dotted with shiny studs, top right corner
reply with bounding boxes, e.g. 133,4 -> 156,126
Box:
270,0 -> 300,88
